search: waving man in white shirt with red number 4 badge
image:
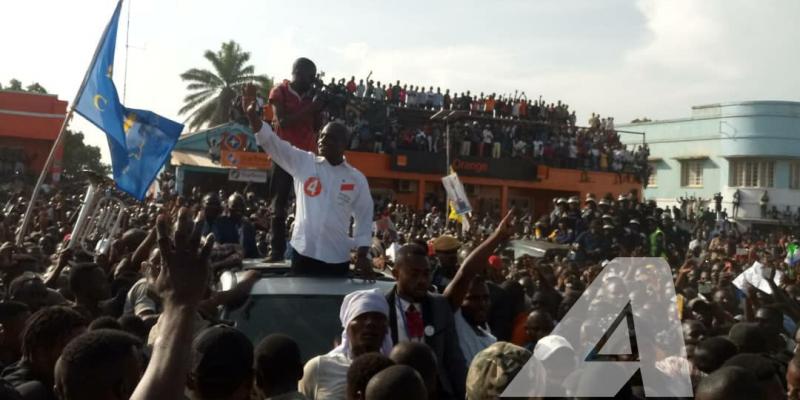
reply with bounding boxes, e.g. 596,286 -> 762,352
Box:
245,99 -> 373,278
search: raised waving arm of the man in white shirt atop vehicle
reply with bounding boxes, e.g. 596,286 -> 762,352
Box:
247,99 -> 315,176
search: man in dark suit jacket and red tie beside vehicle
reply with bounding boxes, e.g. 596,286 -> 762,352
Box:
386,244 -> 467,399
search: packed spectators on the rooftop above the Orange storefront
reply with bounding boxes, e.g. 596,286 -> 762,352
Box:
312,77 -> 650,182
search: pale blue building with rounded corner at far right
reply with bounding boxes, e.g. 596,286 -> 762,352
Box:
617,101 -> 800,225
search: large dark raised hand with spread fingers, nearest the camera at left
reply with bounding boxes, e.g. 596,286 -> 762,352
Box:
156,207 -> 214,307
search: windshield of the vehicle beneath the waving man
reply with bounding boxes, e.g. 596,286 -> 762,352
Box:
226,295 -> 344,362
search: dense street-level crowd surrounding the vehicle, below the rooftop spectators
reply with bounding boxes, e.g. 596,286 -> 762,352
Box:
0,179 -> 800,399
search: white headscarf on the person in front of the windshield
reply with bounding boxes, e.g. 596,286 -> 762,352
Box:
328,289 -> 392,359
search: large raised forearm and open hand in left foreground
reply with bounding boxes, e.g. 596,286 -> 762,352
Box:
131,208 -> 214,400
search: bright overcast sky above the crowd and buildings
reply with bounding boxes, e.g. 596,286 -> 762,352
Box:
0,0 -> 800,160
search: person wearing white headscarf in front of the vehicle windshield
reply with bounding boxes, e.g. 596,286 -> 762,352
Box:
299,289 -> 392,400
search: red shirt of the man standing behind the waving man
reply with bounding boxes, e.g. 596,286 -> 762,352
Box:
269,80 -> 317,153
